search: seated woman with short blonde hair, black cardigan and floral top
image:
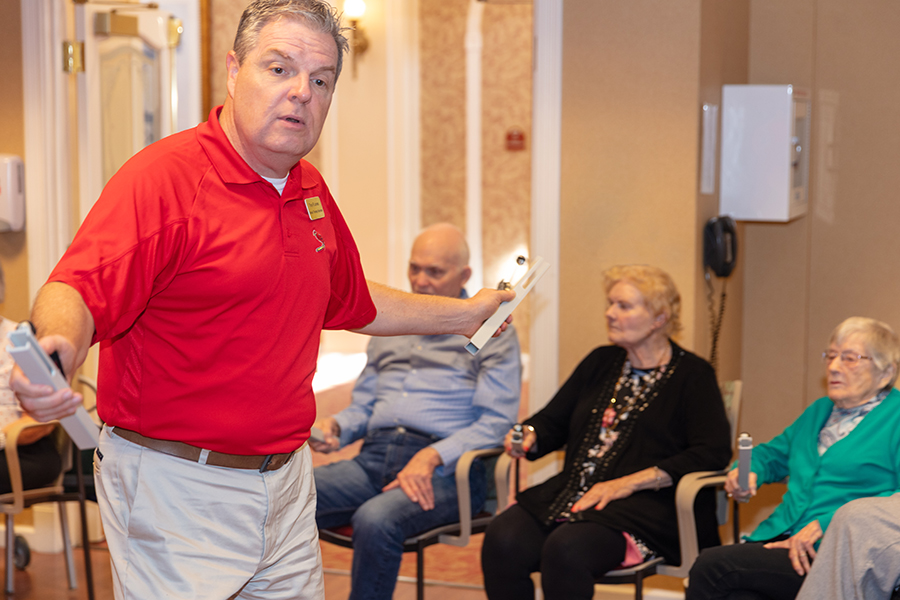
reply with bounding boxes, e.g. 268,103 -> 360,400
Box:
481,265 -> 731,600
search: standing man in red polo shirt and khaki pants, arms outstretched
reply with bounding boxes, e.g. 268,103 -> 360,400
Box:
12,0 -> 512,600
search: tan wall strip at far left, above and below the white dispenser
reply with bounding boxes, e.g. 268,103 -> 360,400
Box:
0,1 -> 29,321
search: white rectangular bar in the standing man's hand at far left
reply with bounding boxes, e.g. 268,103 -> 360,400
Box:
6,323 -> 100,450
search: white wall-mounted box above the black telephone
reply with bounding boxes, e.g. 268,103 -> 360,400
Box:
719,85 -> 810,222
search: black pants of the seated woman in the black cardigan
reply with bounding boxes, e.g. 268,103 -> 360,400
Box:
481,505 -> 625,600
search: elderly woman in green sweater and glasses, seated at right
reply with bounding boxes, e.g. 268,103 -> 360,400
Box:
686,317 -> 900,600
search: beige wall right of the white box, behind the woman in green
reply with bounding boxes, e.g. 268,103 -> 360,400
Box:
743,0 -> 900,440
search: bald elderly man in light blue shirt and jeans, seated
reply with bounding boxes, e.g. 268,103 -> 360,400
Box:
310,223 -> 521,600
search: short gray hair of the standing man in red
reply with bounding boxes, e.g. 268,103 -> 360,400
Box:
233,0 -> 350,82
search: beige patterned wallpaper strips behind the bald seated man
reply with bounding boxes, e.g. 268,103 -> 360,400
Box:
419,0 -> 532,349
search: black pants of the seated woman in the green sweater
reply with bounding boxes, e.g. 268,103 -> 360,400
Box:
685,542 -> 804,600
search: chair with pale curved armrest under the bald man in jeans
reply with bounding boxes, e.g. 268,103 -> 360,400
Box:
319,448 -> 511,600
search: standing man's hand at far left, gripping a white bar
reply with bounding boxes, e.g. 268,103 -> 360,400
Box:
9,335 -> 83,422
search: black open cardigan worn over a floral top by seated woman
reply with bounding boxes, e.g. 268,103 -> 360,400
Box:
518,342 -> 731,564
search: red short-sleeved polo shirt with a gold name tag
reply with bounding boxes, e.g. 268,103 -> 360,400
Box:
50,108 -> 375,454
